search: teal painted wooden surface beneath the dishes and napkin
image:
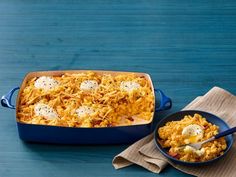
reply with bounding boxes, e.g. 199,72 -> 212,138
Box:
0,0 -> 236,177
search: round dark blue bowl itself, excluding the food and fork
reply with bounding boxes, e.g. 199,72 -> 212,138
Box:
154,110 -> 233,166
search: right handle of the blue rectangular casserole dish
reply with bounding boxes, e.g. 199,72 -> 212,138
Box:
154,89 -> 172,112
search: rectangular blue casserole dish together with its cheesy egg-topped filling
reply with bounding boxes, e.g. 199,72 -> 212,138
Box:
1,70 -> 171,144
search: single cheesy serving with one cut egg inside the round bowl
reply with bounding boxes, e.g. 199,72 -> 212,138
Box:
158,114 -> 227,162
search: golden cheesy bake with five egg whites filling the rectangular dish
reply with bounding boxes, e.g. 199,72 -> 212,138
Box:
17,72 -> 154,127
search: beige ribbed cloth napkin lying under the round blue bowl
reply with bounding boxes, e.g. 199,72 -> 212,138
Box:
112,87 -> 236,177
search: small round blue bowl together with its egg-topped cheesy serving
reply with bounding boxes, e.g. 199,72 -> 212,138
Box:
155,110 -> 233,165
